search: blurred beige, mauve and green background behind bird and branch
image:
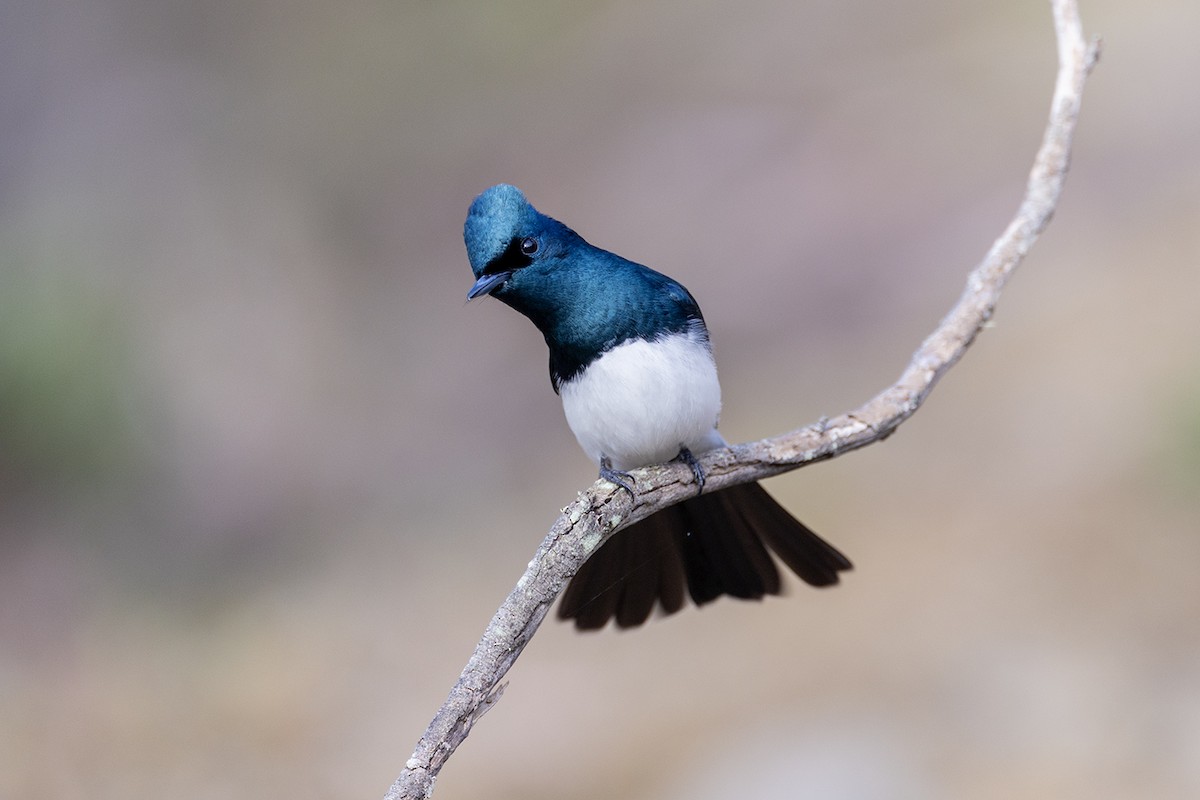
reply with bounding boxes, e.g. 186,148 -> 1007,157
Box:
0,0 -> 1200,800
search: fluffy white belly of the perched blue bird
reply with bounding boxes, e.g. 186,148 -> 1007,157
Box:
559,331 -> 725,470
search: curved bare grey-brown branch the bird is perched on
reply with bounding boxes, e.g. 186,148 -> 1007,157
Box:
386,0 -> 1099,800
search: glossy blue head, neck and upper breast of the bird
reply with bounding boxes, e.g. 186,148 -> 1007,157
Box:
463,184 -> 703,387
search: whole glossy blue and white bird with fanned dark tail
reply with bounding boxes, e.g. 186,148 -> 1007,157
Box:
463,184 -> 852,631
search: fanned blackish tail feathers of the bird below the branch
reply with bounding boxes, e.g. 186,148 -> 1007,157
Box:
558,483 -> 851,631
